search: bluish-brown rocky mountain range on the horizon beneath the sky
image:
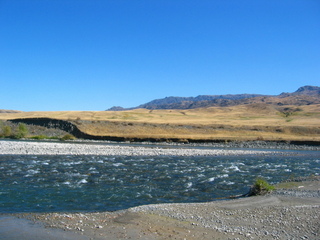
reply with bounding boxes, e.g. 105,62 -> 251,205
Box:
108,86 -> 320,111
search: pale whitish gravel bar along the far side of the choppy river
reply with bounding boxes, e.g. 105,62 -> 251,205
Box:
0,140 -> 281,156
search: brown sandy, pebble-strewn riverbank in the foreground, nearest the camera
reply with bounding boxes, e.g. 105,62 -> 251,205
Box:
5,177 -> 320,240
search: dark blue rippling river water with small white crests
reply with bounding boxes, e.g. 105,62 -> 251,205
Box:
0,145 -> 320,212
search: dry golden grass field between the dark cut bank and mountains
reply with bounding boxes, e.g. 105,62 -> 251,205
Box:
0,103 -> 320,141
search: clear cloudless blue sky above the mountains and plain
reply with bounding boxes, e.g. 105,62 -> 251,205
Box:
0,0 -> 320,111
